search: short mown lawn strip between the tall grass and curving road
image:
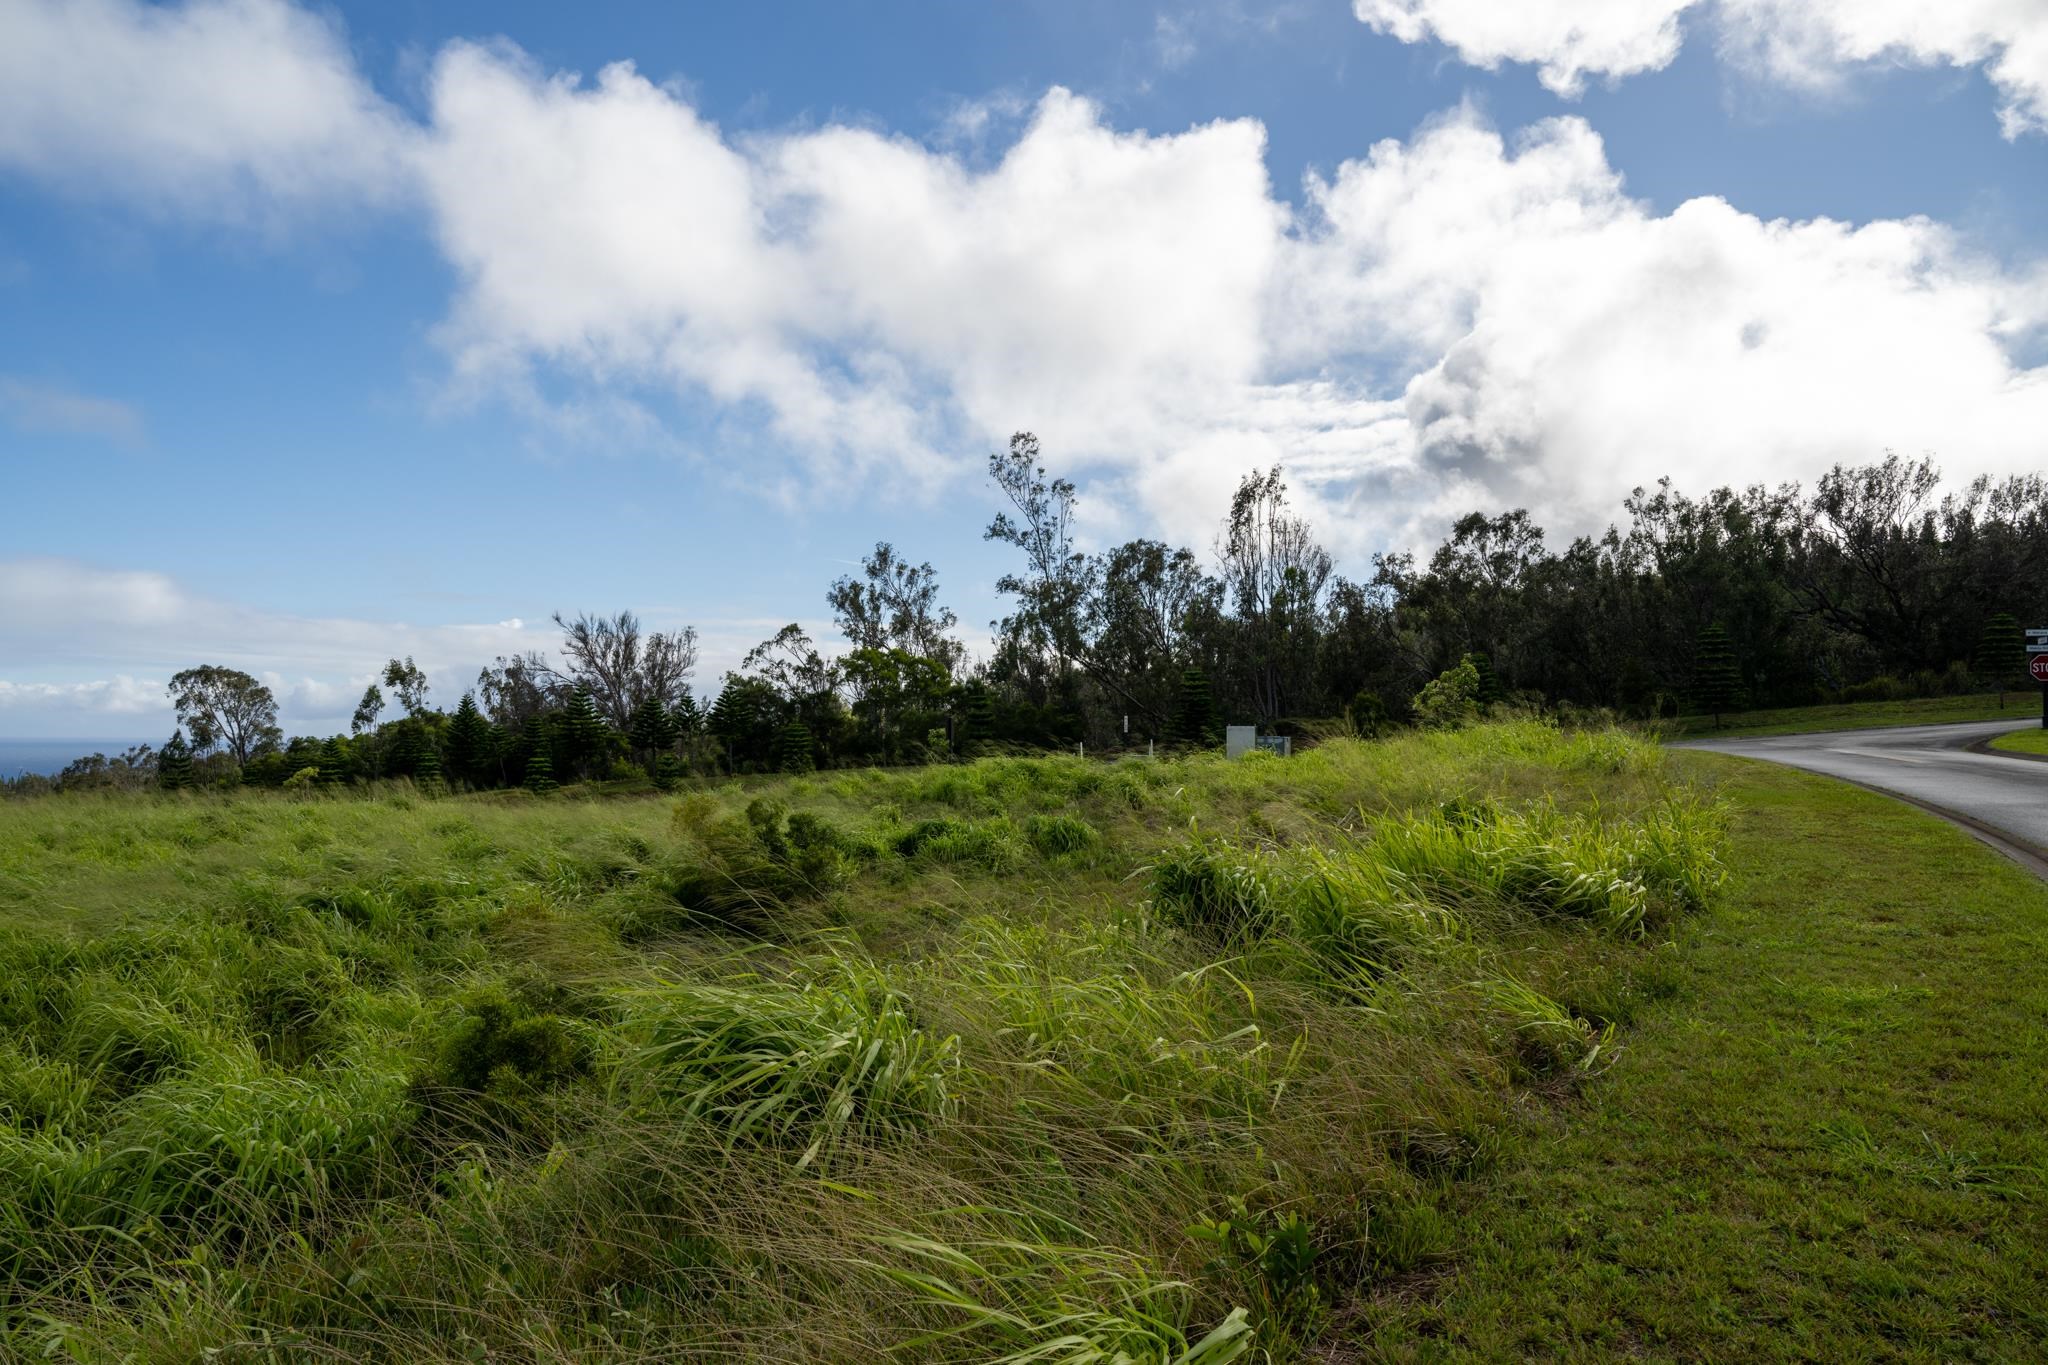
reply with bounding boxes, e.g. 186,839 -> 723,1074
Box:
1360,755 -> 2048,1361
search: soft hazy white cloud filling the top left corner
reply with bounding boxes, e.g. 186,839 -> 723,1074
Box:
0,0 -> 408,221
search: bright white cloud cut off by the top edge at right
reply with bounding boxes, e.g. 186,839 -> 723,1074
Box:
1352,0 -> 2048,137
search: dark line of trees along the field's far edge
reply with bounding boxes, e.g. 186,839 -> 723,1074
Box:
12,432 -> 2048,792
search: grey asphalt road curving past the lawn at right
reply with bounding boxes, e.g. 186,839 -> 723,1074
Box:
1675,716 -> 2048,870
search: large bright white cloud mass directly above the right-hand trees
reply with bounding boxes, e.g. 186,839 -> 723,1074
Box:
1303,113 -> 2048,540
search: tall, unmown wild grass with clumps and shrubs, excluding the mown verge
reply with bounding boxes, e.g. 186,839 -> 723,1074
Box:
0,722 -> 1724,1365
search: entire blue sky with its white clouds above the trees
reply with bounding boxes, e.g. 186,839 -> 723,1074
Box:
0,0 -> 2048,739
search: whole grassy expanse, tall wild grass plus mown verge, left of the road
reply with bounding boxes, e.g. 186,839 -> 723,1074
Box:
0,722 -> 2048,1365
